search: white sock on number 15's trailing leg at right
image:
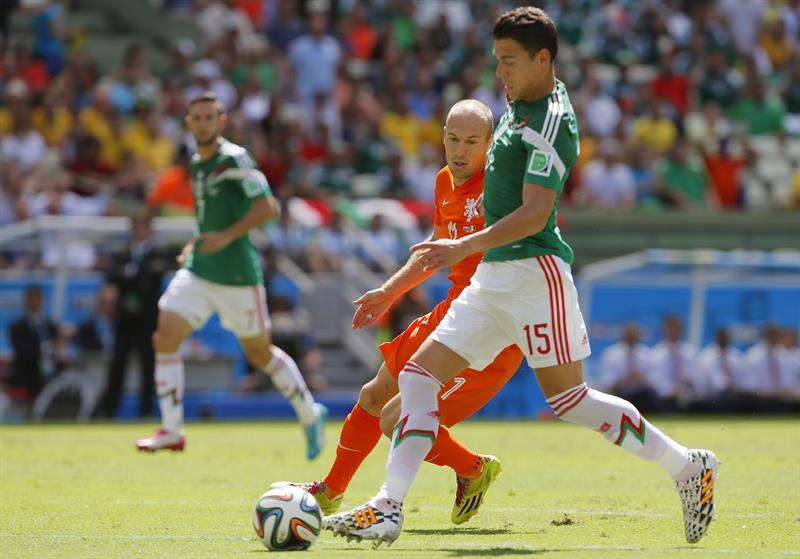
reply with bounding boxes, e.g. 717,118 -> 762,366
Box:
547,383 -> 691,481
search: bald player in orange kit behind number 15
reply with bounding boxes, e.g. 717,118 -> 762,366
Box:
273,99 -> 522,524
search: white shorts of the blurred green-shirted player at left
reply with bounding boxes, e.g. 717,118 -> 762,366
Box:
158,269 -> 271,339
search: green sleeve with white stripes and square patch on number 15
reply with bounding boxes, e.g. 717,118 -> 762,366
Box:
522,120 -> 577,192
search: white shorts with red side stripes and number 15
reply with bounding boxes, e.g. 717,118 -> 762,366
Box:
430,255 -> 591,370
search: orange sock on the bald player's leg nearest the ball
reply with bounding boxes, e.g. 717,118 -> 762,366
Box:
323,403 -> 381,495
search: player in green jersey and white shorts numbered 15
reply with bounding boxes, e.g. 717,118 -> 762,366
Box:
323,7 -> 719,542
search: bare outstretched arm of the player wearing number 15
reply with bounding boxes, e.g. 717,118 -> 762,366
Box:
410,182 -> 556,271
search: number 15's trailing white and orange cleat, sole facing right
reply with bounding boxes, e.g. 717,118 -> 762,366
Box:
675,449 -> 720,543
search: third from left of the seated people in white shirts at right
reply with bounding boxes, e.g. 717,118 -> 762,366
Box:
692,328 -> 742,413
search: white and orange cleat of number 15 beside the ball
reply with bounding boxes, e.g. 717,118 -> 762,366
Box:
322,499 -> 403,547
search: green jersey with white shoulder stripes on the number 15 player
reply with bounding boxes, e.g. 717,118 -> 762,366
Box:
483,80 -> 580,264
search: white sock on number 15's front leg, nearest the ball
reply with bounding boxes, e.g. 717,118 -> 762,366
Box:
375,361 -> 442,503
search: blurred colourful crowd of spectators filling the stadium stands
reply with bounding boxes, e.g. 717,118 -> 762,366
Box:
0,0 -> 800,267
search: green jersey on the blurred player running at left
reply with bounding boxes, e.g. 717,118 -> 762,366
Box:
186,139 -> 272,285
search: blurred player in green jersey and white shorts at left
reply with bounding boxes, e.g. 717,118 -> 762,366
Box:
136,93 -> 327,459
